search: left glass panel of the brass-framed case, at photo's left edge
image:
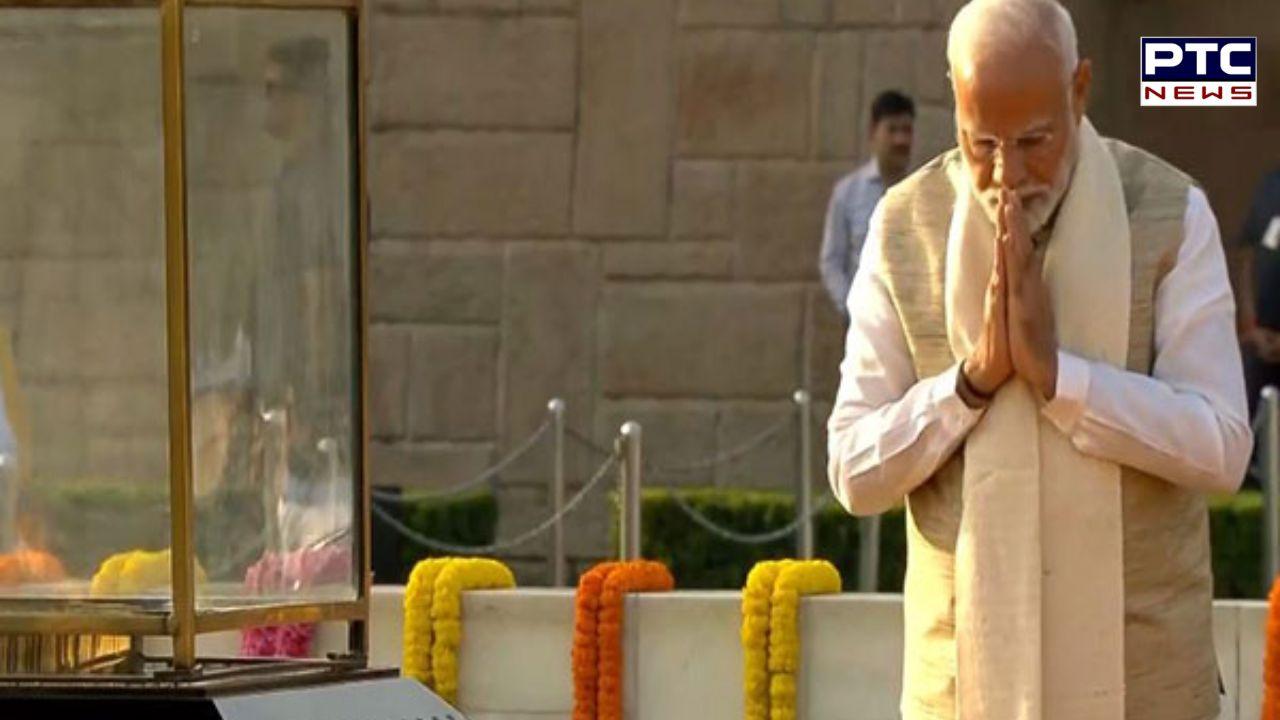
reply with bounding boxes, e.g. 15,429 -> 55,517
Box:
0,9 -> 169,606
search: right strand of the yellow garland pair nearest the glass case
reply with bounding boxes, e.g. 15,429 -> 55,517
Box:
431,559 -> 516,703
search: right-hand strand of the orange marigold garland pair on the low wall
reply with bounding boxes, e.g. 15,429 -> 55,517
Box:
596,560 -> 676,720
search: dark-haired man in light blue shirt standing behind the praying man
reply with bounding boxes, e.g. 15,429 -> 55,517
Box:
819,90 -> 915,319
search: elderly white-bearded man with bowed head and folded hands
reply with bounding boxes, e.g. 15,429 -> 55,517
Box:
828,0 -> 1252,720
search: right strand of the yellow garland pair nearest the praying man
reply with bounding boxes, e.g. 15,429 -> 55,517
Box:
769,560 -> 840,720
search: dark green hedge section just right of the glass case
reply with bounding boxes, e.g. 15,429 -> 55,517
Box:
372,492 -> 498,583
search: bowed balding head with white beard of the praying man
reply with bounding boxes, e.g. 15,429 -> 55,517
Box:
947,0 -> 1093,228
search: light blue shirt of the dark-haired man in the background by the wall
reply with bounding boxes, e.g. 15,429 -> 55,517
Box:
819,160 -> 884,316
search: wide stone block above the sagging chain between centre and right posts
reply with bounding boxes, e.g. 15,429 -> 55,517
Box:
599,283 -> 803,400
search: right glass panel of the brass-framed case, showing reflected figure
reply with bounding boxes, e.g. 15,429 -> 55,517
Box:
187,8 -> 357,609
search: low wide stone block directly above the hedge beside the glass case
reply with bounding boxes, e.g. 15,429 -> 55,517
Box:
369,441 -> 494,492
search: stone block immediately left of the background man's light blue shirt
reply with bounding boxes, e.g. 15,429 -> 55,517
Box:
733,161 -> 847,281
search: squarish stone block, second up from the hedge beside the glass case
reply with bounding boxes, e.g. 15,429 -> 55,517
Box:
408,327 -> 498,441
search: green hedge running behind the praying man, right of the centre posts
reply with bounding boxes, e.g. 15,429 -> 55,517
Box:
634,489 -> 1265,598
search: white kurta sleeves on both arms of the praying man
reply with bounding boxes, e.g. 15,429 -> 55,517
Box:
828,187 -> 1252,514
